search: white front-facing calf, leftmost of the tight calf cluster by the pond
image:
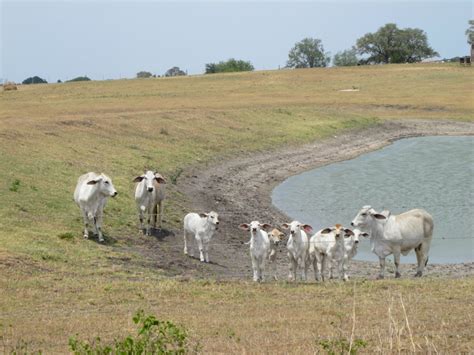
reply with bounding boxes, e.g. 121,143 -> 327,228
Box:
239,221 -> 271,282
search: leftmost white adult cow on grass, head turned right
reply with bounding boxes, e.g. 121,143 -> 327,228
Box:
74,172 -> 117,242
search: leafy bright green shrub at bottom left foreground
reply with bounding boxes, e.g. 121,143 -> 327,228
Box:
69,310 -> 188,355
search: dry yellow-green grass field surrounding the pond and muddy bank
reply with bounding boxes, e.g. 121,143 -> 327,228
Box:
0,64 -> 474,353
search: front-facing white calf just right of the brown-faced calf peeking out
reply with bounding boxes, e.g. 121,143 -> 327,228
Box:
282,221 -> 313,281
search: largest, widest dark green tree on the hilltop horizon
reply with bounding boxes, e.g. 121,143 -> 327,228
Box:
356,23 -> 438,64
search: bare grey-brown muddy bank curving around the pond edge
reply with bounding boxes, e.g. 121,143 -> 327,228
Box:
161,119 -> 474,280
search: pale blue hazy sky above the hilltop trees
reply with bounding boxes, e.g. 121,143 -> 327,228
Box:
0,0 -> 474,82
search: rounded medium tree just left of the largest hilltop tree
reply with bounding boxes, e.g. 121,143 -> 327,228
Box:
286,38 -> 331,68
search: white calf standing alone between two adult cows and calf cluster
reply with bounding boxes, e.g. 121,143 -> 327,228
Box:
184,211 -> 219,263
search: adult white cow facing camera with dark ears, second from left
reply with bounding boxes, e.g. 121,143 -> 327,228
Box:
133,170 -> 166,235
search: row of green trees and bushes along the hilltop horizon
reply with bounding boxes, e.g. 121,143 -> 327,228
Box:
15,20 -> 474,84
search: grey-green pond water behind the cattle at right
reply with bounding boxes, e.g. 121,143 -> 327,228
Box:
272,136 -> 474,263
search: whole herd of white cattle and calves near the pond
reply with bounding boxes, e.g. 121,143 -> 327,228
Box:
74,171 -> 433,282
